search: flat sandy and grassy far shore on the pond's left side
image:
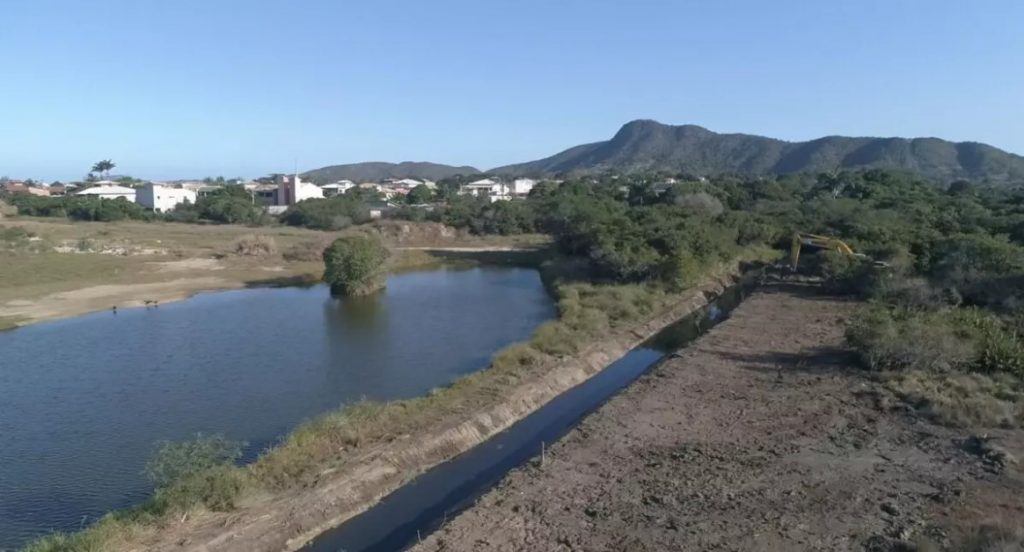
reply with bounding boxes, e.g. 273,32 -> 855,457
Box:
0,218 -> 538,330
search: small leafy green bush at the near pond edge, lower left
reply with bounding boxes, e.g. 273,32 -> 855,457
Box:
145,434 -> 243,510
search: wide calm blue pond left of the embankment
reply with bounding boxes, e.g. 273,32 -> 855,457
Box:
0,268 -> 555,549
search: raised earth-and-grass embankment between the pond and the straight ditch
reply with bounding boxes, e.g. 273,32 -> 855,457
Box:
22,252 -> 761,551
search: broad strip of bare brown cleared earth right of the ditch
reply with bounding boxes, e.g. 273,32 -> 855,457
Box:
414,289 -> 1024,552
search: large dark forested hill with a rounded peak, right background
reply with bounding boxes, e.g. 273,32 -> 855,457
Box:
490,121 -> 1024,183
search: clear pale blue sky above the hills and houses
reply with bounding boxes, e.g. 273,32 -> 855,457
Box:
0,0 -> 1024,179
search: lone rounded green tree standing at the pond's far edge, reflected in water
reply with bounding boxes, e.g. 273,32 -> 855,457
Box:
324,236 -> 388,295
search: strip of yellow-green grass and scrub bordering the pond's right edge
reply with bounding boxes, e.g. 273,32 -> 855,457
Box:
25,248 -> 774,552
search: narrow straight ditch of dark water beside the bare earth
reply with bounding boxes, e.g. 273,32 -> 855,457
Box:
303,284 -> 752,552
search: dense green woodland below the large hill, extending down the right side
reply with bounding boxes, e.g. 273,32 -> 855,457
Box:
430,170 -> 1024,426
